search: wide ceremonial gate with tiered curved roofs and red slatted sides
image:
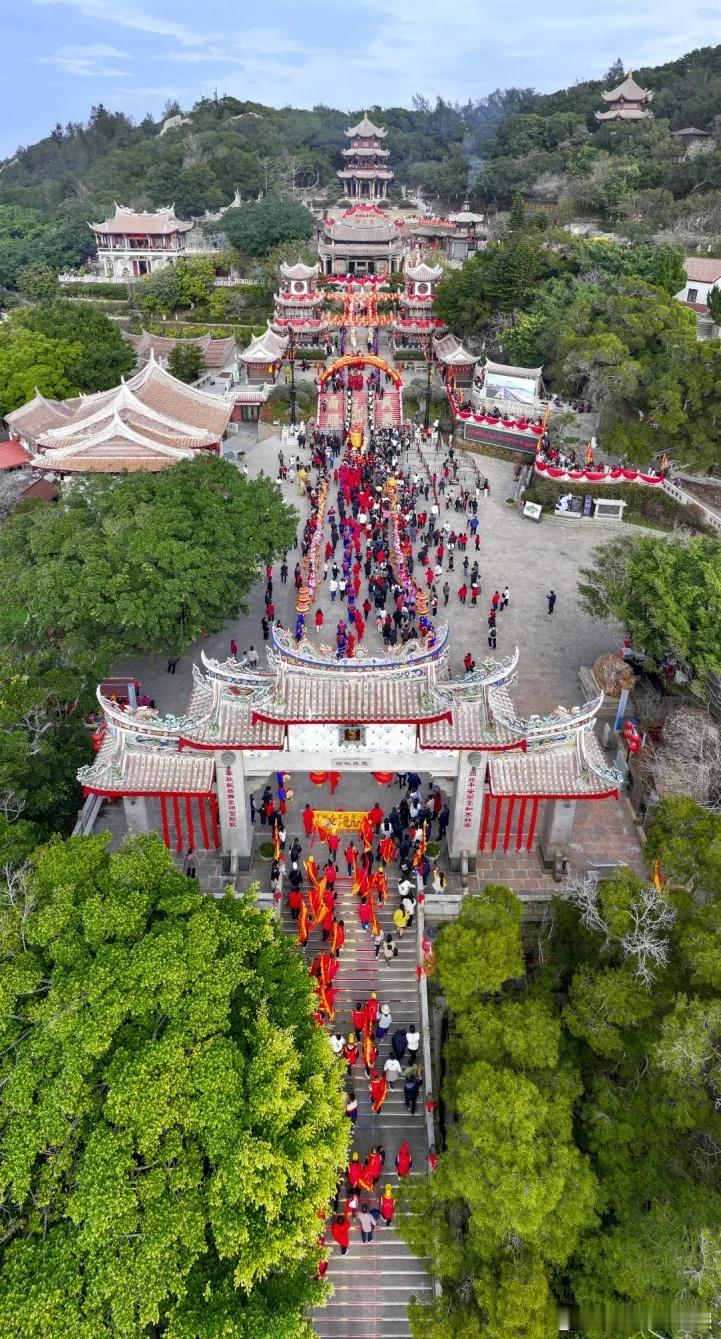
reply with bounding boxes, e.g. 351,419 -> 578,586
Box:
79,627 -> 620,872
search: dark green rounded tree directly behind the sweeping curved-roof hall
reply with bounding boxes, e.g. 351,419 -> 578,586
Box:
11,300 -> 135,395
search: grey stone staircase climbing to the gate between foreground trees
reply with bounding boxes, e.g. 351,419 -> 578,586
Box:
283,867 -> 432,1339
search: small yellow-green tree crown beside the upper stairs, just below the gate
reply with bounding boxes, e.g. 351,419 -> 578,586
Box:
436,884 -> 523,1012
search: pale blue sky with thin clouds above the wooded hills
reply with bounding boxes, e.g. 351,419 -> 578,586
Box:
0,0 -> 721,157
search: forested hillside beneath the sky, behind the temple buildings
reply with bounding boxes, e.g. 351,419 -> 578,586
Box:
0,47 -> 721,288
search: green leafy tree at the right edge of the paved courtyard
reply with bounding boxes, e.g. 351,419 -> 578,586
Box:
579,536 -> 721,680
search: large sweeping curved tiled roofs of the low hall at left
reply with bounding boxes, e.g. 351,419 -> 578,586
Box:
5,349 -> 233,474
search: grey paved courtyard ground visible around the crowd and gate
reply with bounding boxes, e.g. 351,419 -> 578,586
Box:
98,428 -> 642,898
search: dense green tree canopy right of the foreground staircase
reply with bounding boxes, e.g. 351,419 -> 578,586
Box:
402,819 -> 721,1339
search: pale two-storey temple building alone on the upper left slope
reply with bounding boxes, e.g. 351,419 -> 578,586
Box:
88,204 -> 193,280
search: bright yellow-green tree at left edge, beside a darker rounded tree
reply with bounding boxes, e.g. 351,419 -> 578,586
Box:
0,321 -> 83,418
